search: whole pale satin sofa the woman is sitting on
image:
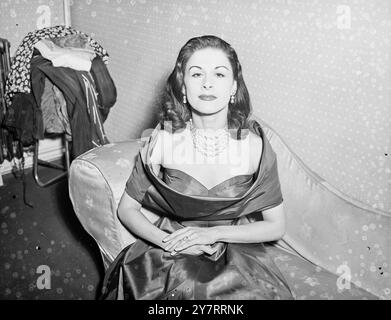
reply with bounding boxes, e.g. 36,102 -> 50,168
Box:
69,118 -> 391,300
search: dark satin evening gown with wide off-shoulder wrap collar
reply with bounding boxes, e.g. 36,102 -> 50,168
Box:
100,119 -> 293,300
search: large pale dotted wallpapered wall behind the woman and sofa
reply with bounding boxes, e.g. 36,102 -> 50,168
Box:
71,0 -> 391,213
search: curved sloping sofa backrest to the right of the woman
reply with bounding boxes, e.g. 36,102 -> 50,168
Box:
257,119 -> 391,299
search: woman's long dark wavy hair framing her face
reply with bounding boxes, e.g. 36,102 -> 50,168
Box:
160,35 -> 251,139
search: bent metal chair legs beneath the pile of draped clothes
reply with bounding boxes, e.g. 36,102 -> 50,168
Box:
33,138 -> 69,188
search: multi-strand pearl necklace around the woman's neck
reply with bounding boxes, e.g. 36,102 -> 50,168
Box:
189,119 -> 229,158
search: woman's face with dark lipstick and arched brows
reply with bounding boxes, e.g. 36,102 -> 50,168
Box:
182,48 -> 236,114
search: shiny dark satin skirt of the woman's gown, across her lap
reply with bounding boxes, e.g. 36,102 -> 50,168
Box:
100,217 -> 293,300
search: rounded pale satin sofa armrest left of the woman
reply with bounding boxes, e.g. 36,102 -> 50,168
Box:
69,140 -> 157,269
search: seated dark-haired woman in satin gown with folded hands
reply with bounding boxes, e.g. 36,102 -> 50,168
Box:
101,36 -> 292,299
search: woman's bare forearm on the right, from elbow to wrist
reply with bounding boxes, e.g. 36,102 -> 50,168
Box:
211,221 -> 285,243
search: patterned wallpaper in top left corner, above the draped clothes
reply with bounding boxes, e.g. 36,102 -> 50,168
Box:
0,0 -> 64,56
